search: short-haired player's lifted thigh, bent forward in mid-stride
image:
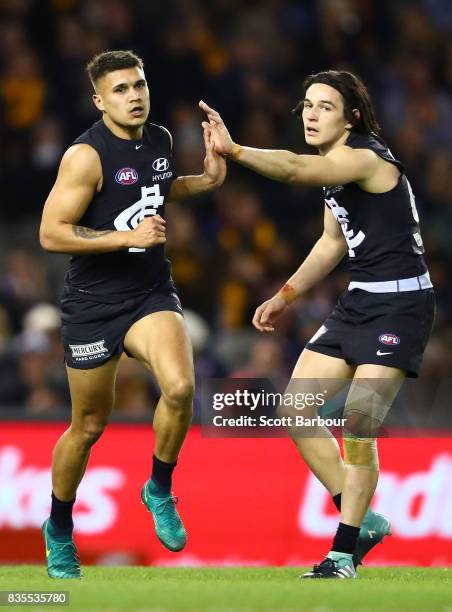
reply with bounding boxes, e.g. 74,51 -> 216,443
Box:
124,311 -> 194,395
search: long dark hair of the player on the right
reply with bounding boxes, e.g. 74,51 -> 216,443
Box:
292,70 -> 381,134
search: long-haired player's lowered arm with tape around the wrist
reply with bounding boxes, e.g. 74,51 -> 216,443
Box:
253,206 -> 347,332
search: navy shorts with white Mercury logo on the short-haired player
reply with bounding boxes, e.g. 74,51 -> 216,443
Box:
61,282 -> 182,370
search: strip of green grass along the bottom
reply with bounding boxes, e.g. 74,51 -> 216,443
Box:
0,566 -> 452,612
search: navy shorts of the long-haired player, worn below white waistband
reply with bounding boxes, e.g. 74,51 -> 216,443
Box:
306,289 -> 435,378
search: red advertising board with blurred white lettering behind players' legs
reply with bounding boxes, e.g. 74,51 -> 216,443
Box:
0,423 -> 452,566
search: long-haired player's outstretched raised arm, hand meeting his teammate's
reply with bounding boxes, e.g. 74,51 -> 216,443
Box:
199,101 -> 399,192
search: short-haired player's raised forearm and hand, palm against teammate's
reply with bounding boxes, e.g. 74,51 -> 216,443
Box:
167,124 -> 226,202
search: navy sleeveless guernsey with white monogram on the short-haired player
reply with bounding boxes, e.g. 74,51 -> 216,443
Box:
65,120 -> 176,301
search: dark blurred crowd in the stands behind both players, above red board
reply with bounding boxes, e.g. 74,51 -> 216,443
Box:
0,0 -> 452,418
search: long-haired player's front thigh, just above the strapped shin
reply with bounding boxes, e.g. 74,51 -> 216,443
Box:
344,364 -> 405,438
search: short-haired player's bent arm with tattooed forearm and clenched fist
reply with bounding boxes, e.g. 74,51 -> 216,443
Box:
39,144 -> 165,255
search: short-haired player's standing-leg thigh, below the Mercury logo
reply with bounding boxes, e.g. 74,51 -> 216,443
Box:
66,355 -> 119,426
